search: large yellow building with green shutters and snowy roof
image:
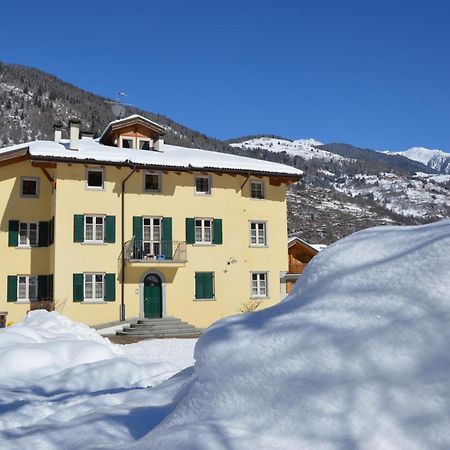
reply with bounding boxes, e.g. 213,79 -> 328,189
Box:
0,115 -> 301,327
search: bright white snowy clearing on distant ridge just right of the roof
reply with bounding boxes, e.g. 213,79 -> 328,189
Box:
230,136 -> 345,161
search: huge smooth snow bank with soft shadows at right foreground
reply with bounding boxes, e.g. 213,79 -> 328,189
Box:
139,220 -> 450,450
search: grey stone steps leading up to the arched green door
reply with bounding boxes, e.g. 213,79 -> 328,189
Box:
116,317 -> 203,339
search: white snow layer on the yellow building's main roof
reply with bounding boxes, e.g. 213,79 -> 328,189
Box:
0,138 -> 303,178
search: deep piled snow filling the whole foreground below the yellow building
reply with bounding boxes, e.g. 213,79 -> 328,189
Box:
0,220 -> 450,450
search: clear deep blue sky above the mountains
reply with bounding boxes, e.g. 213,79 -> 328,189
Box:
0,0 -> 450,151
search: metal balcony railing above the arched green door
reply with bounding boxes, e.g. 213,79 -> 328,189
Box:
123,239 -> 187,263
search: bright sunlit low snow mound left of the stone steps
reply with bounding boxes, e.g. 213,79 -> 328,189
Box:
0,310 -> 196,393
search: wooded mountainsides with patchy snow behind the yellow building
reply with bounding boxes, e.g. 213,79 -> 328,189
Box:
0,62 -> 450,244
